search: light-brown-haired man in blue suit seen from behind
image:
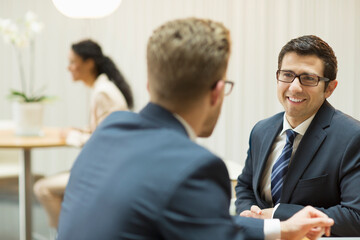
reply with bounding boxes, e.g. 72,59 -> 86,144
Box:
58,18 -> 333,240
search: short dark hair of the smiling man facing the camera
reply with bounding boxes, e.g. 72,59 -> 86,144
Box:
278,35 -> 337,89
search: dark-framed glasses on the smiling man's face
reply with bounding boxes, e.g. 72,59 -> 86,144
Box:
276,70 -> 330,87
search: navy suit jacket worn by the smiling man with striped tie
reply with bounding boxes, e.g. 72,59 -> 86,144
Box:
236,101 -> 360,236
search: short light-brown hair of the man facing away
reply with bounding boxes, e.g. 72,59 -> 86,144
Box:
147,18 -> 230,102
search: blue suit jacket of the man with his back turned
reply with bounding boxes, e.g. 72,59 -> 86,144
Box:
58,103 -> 264,240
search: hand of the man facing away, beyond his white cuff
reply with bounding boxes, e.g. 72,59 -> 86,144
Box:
280,206 -> 334,240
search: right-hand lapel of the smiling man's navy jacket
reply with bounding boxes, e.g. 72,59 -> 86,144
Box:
280,101 -> 335,203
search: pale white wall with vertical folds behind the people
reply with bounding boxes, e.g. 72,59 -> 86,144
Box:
0,0 -> 360,174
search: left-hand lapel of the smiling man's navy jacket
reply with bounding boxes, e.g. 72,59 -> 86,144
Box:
254,114 -> 283,207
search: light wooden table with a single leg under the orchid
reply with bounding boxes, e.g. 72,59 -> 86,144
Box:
0,127 -> 66,240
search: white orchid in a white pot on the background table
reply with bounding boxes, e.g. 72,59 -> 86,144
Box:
0,11 -> 50,135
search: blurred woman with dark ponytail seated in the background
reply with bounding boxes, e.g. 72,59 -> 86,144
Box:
34,40 -> 134,229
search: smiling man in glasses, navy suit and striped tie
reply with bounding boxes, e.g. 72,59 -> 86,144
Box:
236,36 -> 360,236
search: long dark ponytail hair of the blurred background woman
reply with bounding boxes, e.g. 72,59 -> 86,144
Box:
71,39 -> 134,109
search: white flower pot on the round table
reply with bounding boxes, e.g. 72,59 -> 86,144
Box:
12,102 -> 44,136
